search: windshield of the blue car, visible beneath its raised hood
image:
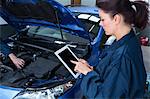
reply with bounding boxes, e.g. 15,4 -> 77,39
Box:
27,26 -> 89,43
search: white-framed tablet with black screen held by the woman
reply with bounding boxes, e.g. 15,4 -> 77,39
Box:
55,45 -> 80,78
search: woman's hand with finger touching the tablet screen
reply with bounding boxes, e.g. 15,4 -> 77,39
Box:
71,59 -> 93,75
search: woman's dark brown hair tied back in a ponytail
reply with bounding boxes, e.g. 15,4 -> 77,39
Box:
96,0 -> 149,29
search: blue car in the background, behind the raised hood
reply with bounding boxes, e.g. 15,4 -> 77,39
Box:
66,5 -> 100,38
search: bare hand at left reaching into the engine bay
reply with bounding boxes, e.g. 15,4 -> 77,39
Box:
9,53 -> 25,69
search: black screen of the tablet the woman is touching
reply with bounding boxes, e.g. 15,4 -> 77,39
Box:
59,49 -> 77,73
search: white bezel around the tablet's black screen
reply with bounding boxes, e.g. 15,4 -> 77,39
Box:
54,45 -> 81,78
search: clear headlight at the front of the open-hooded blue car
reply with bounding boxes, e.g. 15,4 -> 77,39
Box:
14,82 -> 73,99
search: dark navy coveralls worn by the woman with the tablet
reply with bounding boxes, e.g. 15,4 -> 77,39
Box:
81,30 -> 146,99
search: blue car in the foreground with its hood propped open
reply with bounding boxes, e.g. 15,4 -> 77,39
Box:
0,0 -> 103,99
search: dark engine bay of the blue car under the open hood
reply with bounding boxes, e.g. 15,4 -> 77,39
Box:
0,25 -> 89,88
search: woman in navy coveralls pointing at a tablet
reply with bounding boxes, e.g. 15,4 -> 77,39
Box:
71,0 -> 148,99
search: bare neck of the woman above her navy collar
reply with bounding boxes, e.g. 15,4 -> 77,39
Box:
114,26 -> 131,41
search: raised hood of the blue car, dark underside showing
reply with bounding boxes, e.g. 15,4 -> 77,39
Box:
0,0 -> 89,39
